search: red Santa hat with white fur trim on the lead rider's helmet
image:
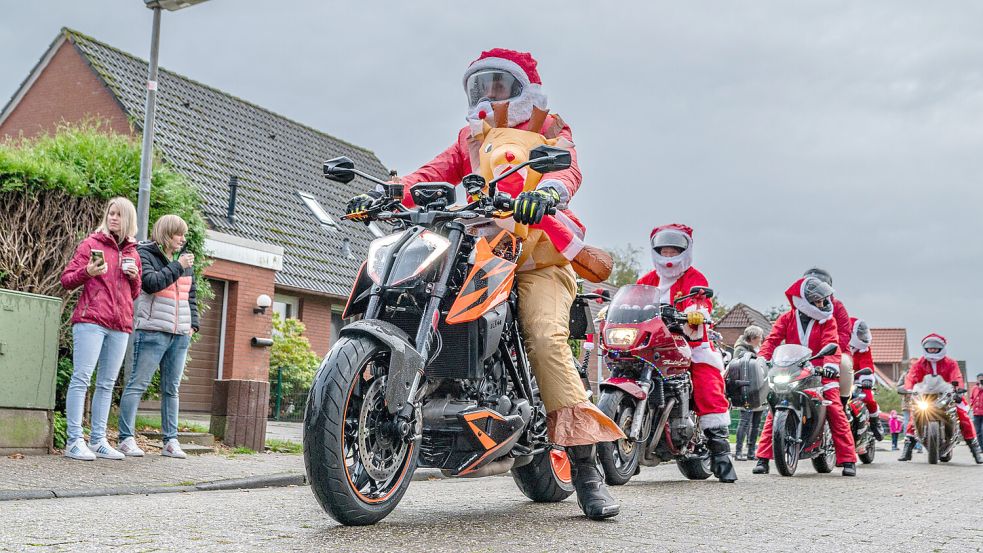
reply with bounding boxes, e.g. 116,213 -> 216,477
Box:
462,48 -> 546,131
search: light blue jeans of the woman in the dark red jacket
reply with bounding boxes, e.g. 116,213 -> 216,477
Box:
65,323 -> 130,443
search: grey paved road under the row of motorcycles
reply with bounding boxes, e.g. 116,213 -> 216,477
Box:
0,446 -> 983,553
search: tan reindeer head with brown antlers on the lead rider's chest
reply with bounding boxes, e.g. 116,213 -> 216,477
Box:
472,102 -> 573,197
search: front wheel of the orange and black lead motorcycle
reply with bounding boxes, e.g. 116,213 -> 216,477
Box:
304,336 -> 418,526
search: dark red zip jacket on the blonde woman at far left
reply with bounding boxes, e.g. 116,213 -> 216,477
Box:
61,232 -> 140,332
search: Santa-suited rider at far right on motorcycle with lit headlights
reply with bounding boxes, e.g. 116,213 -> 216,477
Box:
898,333 -> 983,464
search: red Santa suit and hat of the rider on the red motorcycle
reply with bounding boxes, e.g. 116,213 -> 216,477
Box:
638,225 -> 730,429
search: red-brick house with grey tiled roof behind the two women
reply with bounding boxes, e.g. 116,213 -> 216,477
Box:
0,29 -> 386,449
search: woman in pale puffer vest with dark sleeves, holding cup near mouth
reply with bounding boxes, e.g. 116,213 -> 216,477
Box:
117,215 -> 198,459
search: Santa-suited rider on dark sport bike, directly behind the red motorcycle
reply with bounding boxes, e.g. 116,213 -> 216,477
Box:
752,277 -> 857,476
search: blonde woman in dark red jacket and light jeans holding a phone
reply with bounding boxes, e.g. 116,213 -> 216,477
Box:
61,198 -> 140,461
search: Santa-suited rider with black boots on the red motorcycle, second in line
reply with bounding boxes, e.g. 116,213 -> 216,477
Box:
638,224 -> 737,482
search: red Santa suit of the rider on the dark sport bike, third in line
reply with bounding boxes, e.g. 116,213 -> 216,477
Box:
755,278 -> 857,465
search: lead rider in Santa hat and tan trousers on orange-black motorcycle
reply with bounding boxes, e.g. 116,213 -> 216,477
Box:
347,48 -> 624,519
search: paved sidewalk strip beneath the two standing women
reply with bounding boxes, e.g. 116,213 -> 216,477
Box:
0,452 -> 304,492
